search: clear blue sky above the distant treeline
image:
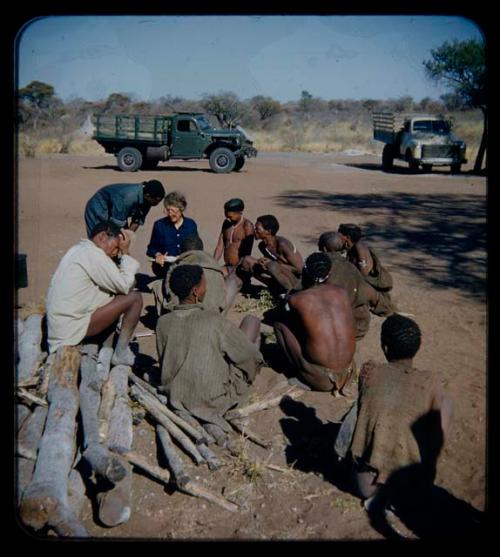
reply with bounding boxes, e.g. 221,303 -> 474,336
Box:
16,15 -> 484,102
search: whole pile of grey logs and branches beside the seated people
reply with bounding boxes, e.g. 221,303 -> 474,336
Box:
16,315 -> 300,537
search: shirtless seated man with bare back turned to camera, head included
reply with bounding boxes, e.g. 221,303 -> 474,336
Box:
274,253 -> 356,396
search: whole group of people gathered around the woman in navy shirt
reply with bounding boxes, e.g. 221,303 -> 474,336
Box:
47,180 -> 450,520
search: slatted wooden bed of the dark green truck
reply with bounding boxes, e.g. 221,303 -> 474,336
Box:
94,114 -> 171,145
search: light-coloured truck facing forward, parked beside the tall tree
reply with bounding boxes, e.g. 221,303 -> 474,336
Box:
372,112 -> 467,174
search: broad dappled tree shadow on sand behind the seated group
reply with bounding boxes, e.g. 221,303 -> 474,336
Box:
274,190 -> 486,300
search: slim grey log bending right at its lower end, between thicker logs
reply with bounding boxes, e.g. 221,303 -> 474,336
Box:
80,344 -> 126,483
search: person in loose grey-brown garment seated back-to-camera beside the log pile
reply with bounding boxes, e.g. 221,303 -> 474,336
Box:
156,265 -> 263,432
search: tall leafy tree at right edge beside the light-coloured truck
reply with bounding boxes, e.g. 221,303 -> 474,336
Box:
423,39 -> 488,172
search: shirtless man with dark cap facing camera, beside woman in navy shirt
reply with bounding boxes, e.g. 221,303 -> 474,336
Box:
214,198 -> 254,274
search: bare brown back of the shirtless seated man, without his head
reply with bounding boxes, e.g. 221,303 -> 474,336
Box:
288,284 -> 356,371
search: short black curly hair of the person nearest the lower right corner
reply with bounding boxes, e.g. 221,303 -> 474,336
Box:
380,313 -> 422,360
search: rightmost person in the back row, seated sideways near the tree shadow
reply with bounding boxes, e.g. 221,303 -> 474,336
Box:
338,224 -> 393,292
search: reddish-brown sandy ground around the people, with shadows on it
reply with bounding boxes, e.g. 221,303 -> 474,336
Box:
18,153 -> 487,540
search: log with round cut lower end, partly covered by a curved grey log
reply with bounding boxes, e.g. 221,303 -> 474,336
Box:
98,365 -> 133,526
